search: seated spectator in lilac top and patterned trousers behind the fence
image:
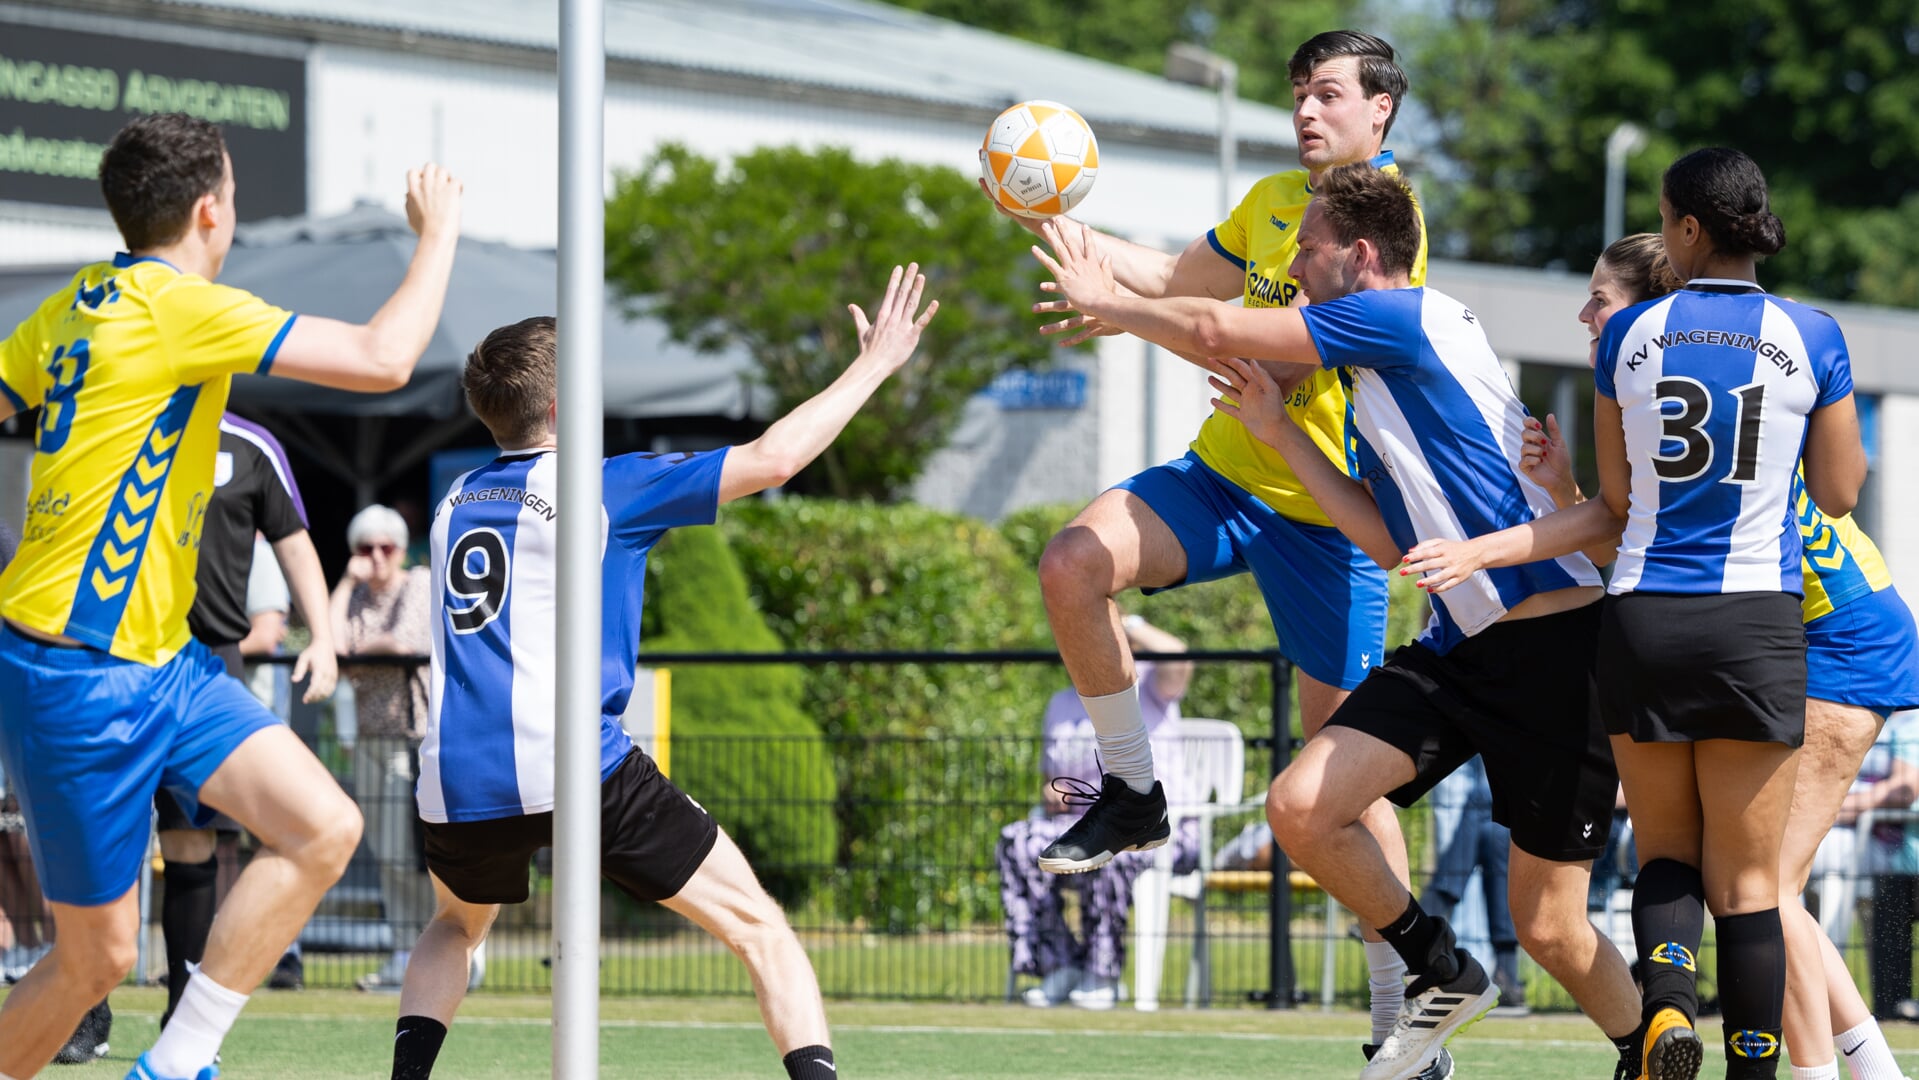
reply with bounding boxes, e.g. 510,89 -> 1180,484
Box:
994,616 -> 1197,1009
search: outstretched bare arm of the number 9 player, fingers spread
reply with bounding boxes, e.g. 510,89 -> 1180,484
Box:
720,263 -> 940,503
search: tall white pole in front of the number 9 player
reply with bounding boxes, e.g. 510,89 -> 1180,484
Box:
553,0 -> 606,1080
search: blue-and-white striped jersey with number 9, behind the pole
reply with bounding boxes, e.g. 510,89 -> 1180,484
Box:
418,443 -> 725,821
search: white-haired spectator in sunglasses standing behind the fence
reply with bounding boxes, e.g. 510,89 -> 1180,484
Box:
332,505 -> 434,994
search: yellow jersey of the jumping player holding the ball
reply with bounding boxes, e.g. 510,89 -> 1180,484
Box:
1192,152 -> 1426,526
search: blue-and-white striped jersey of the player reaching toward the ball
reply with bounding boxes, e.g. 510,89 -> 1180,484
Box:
1301,288 -> 1599,652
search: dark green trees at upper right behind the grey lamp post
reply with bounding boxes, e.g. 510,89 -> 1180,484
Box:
1409,0 -> 1919,305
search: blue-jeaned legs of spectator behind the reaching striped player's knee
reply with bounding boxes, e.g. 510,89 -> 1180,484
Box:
1420,756 -> 1528,1017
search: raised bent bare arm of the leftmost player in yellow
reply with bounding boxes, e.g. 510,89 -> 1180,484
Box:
271,165 -> 462,391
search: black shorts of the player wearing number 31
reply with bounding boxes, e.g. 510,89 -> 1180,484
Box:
1599,593 -> 1806,746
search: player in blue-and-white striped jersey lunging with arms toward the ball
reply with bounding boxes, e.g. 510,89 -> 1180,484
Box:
1036,165 -> 1639,1080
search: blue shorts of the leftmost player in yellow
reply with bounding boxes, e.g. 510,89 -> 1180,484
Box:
0,627 -> 278,905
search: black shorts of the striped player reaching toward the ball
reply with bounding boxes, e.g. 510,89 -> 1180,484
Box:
1328,604 -> 1620,863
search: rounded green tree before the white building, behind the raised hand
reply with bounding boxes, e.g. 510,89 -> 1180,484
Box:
606,144 -> 1048,499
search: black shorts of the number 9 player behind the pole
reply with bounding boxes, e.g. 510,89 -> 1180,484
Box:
422,750 -> 720,904
